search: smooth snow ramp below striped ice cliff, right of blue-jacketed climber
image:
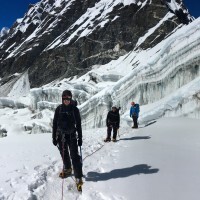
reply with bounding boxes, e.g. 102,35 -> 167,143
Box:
136,77 -> 200,123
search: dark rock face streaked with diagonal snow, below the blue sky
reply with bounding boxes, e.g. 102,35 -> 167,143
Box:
0,0 -> 192,87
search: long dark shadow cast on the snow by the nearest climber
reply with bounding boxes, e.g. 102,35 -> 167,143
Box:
85,164 -> 159,182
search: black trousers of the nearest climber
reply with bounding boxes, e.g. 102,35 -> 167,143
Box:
58,133 -> 83,178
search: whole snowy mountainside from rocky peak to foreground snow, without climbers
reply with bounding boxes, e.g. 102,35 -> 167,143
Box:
0,0 -> 200,200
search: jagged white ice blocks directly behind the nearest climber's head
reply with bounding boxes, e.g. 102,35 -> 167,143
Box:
30,79 -> 99,110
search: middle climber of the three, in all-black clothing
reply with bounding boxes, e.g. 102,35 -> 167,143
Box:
104,106 -> 120,142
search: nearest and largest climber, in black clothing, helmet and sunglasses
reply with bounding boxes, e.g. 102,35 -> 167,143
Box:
52,90 -> 83,181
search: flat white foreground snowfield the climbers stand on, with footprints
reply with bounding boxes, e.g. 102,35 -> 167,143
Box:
0,116 -> 200,200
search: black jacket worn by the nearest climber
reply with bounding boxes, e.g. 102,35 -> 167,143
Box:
52,104 -> 82,139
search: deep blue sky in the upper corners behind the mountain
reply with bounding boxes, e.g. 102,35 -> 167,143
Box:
0,0 -> 200,30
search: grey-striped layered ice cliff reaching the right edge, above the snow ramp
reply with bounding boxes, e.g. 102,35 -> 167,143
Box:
112,19 -> 200,110
